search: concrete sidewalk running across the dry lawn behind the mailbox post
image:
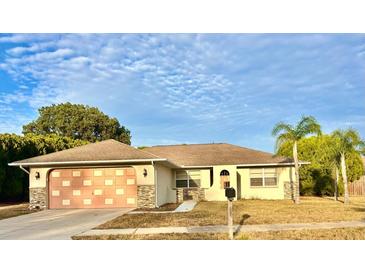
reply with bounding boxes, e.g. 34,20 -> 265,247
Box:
77,218 -> 365,236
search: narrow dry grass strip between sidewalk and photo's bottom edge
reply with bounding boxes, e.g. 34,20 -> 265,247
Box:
72,228 -> 365,240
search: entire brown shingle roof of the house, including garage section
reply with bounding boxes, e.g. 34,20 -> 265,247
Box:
10,140 -> 292,166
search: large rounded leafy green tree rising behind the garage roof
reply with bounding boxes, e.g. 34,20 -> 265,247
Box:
23,103 -> 131,145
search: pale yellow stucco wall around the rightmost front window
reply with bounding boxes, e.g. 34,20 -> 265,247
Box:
237,167 -> 290,200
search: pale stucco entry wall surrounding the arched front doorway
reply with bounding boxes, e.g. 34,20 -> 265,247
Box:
205,165 -> 237,201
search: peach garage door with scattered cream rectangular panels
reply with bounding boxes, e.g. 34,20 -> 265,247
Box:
49,168 -> 137,208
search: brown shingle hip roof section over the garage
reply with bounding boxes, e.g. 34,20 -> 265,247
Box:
12,140 -> 163,164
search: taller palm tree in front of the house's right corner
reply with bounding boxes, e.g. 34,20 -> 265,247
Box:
272,116 -> 321,204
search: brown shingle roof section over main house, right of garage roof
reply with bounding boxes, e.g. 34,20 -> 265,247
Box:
143,144 -> 293,166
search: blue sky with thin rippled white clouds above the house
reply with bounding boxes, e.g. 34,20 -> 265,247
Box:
0,34 -> 365,151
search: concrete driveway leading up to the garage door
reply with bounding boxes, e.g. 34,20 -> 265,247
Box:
0,208 -> 131,240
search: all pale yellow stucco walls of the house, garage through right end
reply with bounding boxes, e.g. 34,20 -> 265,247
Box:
29,164 -> 294,206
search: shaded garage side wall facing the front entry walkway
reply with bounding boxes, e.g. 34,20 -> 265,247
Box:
155,164 -> 176,206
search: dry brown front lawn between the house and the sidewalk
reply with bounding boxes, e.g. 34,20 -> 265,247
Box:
97,197 -> 365,229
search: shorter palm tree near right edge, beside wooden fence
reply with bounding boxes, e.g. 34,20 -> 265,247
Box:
332,128 -> 365,204
